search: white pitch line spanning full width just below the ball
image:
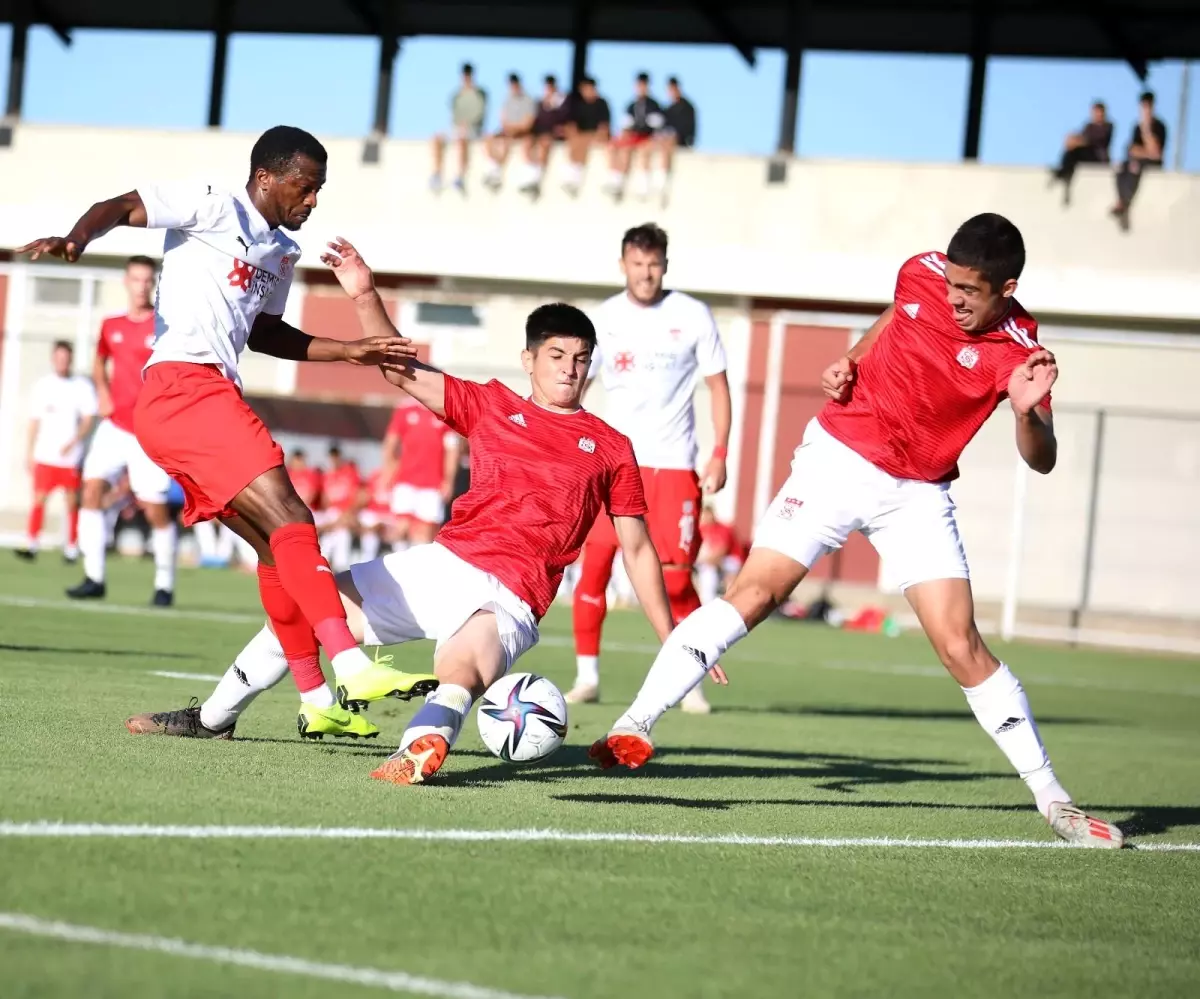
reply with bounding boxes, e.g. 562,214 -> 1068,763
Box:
0,821 -> 1200,853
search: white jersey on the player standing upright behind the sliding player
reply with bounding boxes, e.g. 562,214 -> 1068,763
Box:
588,292 -> 725,469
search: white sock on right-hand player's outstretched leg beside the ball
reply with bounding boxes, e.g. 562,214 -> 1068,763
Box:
613,600 -> 746,732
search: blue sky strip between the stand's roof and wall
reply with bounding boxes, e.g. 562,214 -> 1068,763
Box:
0,25 -> 1200,172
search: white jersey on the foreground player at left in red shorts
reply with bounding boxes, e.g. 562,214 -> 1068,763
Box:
138,184 -> 300,387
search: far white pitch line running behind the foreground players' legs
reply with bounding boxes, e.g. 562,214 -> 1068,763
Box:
0,594 -> 1200,698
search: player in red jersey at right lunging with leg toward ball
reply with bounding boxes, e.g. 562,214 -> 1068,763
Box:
592,215 -> 1123,848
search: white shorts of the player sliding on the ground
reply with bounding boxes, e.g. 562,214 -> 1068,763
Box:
350,543 -> 538,671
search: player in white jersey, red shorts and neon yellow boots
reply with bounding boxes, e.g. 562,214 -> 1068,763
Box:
18,126 -> 433,735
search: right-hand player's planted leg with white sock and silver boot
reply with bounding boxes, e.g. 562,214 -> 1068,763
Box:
905,579 -> 1124,848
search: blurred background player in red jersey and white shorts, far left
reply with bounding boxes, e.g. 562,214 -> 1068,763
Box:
67,257 -> 179,608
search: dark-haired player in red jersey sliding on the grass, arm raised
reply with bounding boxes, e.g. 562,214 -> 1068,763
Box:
131,243 -> 705,784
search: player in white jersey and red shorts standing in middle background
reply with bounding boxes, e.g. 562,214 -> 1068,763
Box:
566,225 -> 731,713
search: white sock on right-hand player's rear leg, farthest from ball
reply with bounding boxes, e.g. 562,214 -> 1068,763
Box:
962,663 -> 1070,815
